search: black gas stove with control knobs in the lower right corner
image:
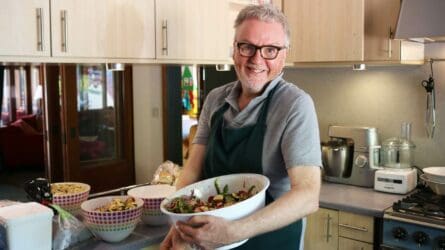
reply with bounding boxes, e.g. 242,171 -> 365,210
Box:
382,187 -> 445,250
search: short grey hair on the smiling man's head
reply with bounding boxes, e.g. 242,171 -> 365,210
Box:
234,4 -> 290,48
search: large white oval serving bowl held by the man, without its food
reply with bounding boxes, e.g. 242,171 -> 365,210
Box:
161,174 -> 270,250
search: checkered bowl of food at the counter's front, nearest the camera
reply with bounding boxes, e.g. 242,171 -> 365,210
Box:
81,196 -> 144,242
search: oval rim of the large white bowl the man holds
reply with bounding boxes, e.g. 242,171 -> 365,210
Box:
160,173 -> 270,217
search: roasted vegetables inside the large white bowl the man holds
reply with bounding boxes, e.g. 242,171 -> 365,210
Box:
165,179 -> 257,214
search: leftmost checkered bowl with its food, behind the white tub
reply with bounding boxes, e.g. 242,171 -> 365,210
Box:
51,182 -> 91,214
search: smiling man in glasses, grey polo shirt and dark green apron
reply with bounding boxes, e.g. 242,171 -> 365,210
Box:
161,5 -> 321,249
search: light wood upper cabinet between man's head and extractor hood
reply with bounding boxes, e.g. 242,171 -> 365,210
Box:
283,0 -> 424,63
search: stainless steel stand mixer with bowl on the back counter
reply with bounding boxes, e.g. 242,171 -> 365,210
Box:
322,126 -> 380,187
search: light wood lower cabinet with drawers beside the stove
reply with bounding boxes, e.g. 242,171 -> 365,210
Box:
304,208 -> 374,250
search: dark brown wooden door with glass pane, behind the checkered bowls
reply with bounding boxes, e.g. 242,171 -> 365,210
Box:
47,64 -> 135,192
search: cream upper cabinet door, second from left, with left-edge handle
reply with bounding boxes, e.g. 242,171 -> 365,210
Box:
51,0 -> 155,59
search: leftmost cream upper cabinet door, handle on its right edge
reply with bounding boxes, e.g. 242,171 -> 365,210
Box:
0,0 -> 51,57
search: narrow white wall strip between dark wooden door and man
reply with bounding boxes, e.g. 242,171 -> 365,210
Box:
133,65 -> 164,183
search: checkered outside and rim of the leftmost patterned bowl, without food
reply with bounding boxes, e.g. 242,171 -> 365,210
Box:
51,182 -> 91,214
